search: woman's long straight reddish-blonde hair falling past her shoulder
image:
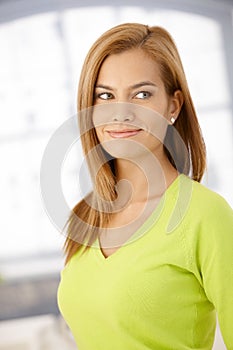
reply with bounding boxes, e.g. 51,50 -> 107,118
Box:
64,23 -> 206,262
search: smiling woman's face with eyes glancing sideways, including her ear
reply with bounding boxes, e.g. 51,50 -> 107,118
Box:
93,49 -> 180,158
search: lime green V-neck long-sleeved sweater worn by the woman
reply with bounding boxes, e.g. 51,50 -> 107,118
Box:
58,175 -> 233,350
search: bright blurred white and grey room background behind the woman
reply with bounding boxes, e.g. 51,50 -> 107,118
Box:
0,0 -> 233,350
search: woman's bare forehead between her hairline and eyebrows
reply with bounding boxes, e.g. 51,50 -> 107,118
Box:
97,49 -> 161,85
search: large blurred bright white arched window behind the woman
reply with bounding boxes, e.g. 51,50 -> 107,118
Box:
0,2 -> 233,259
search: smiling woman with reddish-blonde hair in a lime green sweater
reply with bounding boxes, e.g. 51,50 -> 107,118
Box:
58,23 -> 233,350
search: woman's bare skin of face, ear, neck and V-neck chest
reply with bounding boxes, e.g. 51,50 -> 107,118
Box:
93,49 -> 183,257
